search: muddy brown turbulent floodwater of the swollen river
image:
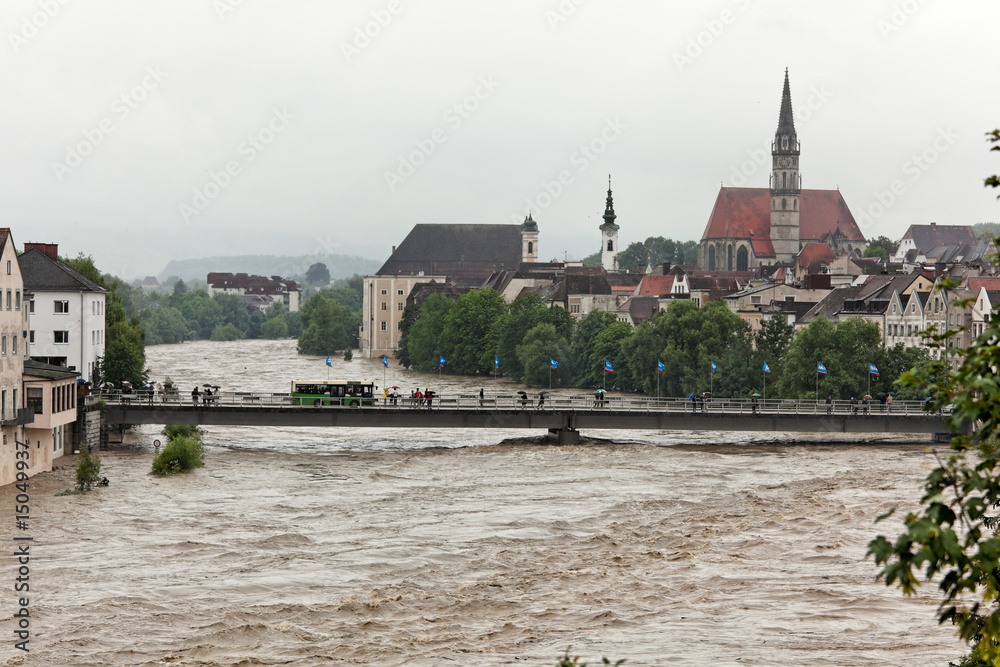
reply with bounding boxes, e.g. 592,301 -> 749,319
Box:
0,341 -> 964,667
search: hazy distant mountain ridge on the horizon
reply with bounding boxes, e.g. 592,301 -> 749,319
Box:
156,255 -> 382,282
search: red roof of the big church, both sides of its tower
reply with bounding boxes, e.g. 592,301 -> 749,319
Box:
702,187 -> 865,245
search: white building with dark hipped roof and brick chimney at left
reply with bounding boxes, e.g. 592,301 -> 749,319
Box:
17,243 -> 106,380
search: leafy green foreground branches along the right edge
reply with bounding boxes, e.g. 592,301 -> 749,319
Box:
868,138 -> 1000,666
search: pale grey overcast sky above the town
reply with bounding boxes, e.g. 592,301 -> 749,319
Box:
0,0 -> 1000,277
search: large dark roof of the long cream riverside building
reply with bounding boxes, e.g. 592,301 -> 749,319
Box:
376,224 -> 521,285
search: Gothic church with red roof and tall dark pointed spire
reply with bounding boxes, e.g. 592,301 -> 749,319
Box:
698,69 -> 867,271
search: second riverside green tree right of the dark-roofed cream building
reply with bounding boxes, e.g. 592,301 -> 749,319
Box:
441,289 -> 507,375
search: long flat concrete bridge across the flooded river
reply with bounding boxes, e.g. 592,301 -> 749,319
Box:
102,393 -> 950,444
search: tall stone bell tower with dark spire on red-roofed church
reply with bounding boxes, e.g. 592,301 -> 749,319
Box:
771,68 -> 802,264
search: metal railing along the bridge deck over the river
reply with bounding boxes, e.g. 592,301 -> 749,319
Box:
94,390 -> 926,415
